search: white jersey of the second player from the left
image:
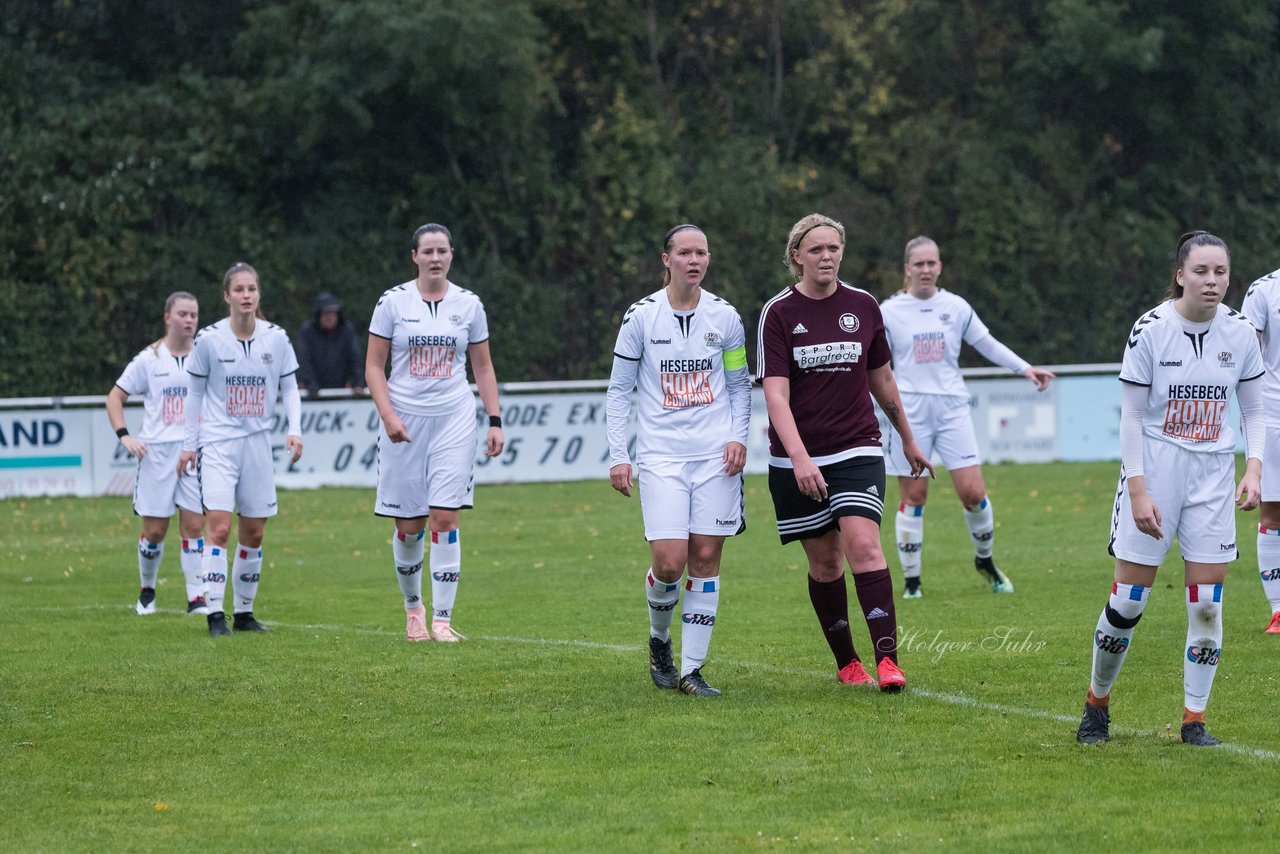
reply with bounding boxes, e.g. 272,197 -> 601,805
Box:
187,318 -> 298,446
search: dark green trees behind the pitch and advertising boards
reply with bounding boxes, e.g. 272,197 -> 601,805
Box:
0,0 -> 1280,397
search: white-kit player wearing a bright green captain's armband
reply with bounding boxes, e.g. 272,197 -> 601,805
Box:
605,224 -> 751,697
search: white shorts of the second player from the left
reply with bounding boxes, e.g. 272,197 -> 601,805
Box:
198,430 -> 276,519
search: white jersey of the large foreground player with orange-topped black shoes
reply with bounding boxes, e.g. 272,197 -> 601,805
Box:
1120,300 -> 1263,453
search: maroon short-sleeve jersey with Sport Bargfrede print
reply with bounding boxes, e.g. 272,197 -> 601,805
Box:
756,282 -> 890,467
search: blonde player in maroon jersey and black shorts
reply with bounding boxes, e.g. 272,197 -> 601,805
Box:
756,214 -> 933,691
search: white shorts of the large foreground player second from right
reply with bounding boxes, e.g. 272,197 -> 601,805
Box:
1107,437 -> 1235,566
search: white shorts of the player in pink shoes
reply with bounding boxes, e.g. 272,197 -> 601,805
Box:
374,399 -> 479,519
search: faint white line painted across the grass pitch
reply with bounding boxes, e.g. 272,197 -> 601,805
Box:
33,604 -> 1280,762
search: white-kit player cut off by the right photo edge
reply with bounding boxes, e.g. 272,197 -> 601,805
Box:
1240,270 -> 1280,635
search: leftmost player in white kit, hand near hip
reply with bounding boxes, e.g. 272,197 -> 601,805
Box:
106,291 -> 206,615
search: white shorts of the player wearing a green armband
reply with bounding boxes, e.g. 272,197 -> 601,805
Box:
636,457 -> 746,542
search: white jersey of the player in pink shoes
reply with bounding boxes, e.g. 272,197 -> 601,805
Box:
369,280 -> 489,415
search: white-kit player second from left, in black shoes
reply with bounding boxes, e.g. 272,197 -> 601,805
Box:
178,262 -> 302,638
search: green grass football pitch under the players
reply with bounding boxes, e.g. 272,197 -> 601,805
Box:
0,463 -> 1280,851
